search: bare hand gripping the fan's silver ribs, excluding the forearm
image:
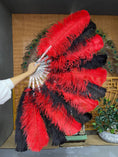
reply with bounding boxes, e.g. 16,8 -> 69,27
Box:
27,62 -> 40,75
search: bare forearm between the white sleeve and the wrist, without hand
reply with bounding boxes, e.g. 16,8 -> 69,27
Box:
11,72 -> 30,86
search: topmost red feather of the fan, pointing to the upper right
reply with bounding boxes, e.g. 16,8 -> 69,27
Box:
37,10 -> 90,57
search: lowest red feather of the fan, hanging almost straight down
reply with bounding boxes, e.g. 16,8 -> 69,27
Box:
21,94 -> 49,151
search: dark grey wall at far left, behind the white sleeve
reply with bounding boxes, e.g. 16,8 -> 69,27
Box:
0,2 -> 13,145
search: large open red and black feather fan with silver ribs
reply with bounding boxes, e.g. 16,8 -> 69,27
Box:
16,10 -> 106,151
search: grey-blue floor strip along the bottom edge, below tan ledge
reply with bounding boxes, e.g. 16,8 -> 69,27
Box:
0,146 -> 118,157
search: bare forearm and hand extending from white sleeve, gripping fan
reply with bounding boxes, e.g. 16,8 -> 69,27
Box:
10,62 -> 40,86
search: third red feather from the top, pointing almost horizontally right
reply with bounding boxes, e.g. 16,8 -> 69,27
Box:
45,68 -> 107,94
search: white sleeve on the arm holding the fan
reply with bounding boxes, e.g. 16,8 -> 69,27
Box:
0,79 -> 14,105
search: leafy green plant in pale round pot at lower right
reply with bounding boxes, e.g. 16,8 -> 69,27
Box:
92,97 -> 118,143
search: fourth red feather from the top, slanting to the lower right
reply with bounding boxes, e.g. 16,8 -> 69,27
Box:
46,79 -> 98,114
